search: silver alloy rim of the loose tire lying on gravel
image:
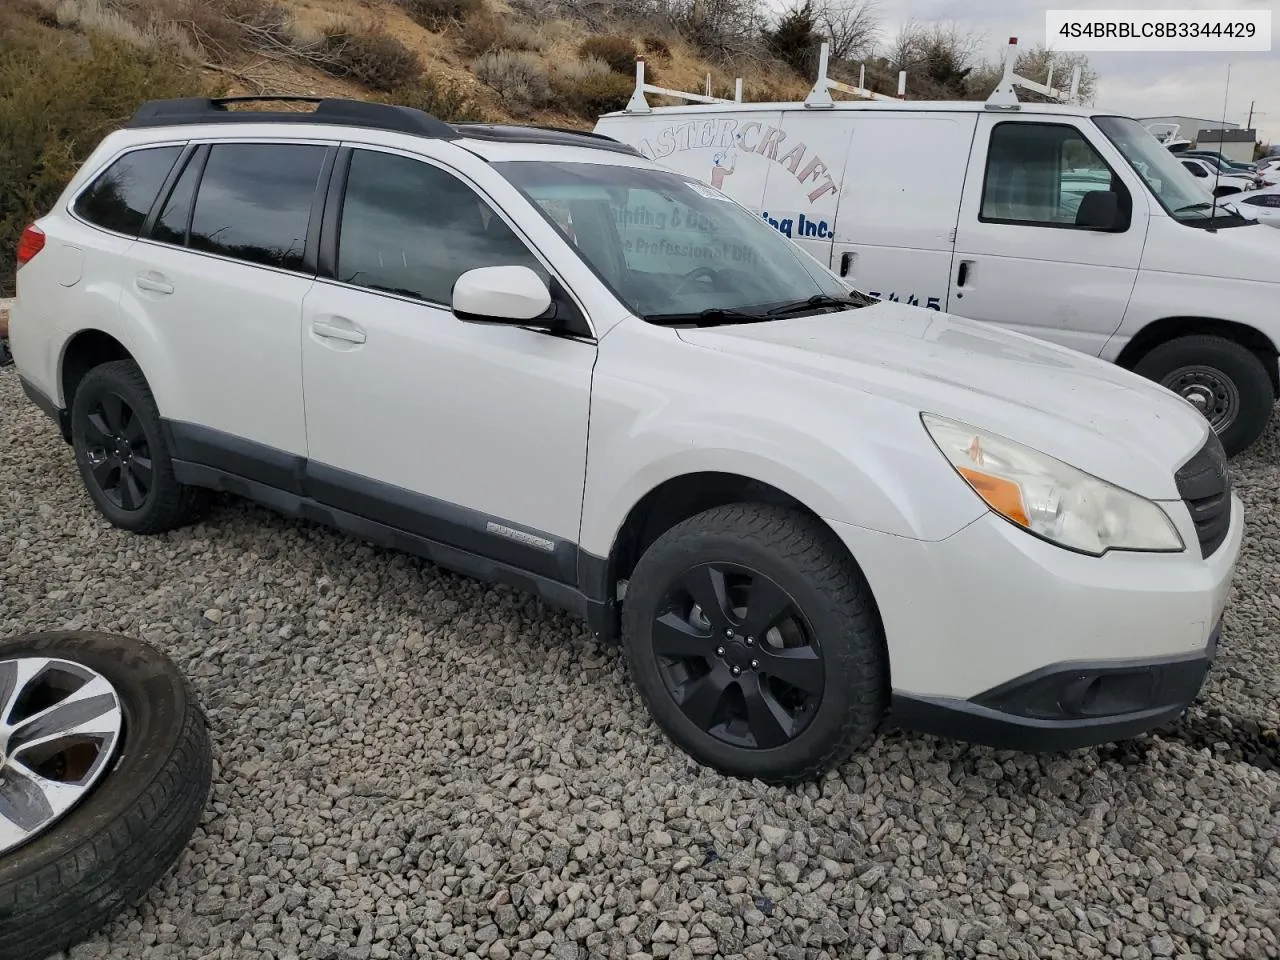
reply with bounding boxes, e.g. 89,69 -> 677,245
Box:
0,657 -> 124,855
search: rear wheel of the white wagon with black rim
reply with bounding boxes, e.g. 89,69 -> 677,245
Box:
70,360 -> 209,534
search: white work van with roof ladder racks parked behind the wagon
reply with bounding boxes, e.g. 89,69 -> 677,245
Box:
595,40 -> 1280,453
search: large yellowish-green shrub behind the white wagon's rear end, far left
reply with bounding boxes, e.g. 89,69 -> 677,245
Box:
0,27 -> 202,294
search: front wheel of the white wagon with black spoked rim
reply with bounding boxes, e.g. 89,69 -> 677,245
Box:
622,503 -> 888,782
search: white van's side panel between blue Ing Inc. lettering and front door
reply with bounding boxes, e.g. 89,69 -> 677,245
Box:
813,110 -> 977,310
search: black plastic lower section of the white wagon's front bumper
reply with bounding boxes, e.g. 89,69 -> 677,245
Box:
890,626 -> 1221,753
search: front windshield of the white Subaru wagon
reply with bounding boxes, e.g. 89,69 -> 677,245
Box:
494,160 -> 867,325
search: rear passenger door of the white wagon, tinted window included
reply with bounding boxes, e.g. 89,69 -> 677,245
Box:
120,141 -> 335,463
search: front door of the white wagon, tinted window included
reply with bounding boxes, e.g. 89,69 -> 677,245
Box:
302,142 -> 595,581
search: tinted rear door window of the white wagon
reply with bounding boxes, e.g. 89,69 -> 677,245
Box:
189,143 -> 325,270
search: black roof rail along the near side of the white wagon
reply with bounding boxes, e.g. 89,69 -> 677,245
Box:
124,96 -> 458,140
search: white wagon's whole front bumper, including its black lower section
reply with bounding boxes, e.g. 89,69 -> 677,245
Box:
832,493 -> 1244,751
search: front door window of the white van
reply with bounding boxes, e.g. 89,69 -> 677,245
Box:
978,122 -> 1129,227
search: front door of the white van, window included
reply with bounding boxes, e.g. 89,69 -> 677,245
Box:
950,115 -> 1147,356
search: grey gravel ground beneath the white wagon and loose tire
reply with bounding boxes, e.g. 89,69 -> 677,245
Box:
0,367 -> 1280,960
